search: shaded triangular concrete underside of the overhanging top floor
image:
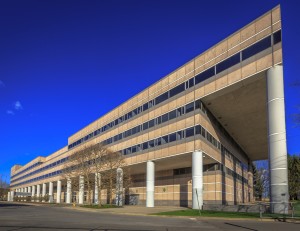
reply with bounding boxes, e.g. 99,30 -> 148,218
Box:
201,71 -> 268,161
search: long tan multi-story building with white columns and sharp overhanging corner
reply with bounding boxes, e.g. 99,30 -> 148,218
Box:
10,6 -> 288,212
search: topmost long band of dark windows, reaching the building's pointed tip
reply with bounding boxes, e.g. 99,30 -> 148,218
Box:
68,30 -> 281,149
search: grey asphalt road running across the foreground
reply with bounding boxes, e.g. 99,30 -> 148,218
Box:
0,202 -> 300,231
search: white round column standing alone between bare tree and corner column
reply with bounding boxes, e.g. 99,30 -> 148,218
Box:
146,161 -> 155,207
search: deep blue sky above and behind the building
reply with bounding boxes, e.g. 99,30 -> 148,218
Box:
0,0 -> 300,183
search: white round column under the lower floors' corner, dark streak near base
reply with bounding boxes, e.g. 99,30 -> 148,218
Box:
192,151 -> 203,209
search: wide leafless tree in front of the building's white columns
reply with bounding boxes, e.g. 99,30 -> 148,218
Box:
64,143 -> 130,206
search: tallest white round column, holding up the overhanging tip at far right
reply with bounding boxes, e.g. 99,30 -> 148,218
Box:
267,66 -> 289,213
